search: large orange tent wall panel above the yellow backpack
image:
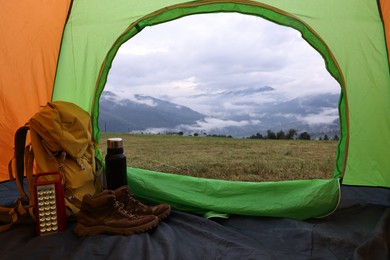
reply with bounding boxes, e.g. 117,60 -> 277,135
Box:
0,0 -> 71,180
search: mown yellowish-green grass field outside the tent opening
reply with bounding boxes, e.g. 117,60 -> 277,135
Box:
100,133 -> 337,181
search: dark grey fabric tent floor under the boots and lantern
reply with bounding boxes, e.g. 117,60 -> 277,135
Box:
0,182 -> 390,259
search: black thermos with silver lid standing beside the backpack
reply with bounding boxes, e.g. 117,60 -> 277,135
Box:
105,138 -> 127,190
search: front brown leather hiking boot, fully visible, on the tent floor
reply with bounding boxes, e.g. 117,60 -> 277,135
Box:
74,191 -> 159,236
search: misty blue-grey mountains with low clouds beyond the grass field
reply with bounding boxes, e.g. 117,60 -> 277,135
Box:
99,86 -> 339,137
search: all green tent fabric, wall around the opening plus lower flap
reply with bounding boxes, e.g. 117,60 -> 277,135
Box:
47,0 -> 390,218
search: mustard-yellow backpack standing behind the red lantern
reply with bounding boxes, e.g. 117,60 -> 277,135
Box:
0,101 -> 103,231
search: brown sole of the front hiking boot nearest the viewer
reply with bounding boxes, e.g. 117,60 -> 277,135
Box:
74,219 -> 159,237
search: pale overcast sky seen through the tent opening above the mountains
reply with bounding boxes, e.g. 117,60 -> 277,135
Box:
105,13 -> 340,120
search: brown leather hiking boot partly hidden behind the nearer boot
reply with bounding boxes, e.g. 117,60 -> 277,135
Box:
114,185 -> 171,221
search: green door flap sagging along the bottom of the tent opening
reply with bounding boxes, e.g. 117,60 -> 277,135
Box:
128,168 -> 340,220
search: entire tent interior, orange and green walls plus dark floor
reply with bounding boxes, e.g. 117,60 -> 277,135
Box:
0,0 -> 390,259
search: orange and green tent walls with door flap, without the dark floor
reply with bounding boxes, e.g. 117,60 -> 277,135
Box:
0,0 -> 390,228
